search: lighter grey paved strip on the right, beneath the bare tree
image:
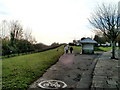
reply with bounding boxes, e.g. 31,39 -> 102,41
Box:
91,51 -> 120,90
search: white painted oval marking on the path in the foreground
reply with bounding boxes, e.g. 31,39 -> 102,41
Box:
38,80 -> 67,89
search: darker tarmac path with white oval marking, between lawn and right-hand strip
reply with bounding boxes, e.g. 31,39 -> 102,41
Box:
29,53 -> 99,89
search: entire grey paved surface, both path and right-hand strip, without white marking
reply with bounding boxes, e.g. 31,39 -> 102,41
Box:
29,51 -> 120,90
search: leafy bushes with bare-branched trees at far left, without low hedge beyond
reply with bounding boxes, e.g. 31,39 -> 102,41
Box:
0,20 -> 35,57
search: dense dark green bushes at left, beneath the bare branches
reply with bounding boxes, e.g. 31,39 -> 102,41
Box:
2,39 -> 35,56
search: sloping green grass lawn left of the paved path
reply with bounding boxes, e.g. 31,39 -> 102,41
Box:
2,46 -> 64,89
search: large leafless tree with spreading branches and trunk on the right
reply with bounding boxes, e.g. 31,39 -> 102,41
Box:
89,4 -> 120,59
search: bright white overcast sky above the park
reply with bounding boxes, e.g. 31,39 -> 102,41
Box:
0,0 -> 120,45
